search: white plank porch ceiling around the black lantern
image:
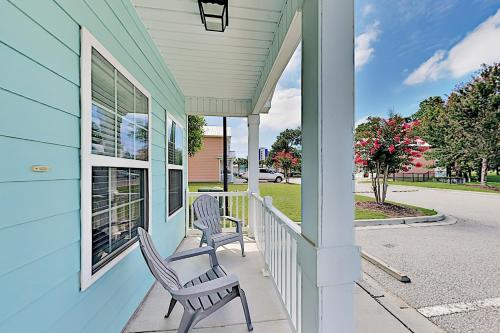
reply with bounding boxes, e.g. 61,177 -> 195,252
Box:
132,0 -> 298,116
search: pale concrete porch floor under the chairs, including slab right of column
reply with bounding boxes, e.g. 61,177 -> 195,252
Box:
123,237 -> 408,333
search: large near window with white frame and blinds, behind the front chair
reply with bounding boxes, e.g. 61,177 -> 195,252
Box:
81,29 -> 151,290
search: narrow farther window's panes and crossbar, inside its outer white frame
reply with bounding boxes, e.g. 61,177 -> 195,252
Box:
167,118 -> 184,216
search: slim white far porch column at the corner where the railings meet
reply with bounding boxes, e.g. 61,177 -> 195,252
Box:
248,114 -> 260,237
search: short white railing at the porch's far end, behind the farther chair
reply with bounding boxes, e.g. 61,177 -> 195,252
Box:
186,191 -> 248,231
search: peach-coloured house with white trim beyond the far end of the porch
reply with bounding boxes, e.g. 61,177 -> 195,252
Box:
188,126 -> 235,182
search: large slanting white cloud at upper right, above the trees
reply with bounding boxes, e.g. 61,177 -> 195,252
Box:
404,10 -> 500,85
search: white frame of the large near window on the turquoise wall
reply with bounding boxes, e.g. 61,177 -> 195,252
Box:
80,27 -> 152,291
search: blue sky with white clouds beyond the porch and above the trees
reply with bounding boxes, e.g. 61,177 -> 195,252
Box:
206,0 -> 500,157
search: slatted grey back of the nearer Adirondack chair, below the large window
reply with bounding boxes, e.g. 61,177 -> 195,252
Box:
139,228 -> 182,291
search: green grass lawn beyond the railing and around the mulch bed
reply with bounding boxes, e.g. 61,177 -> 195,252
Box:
189,183 -> 436,222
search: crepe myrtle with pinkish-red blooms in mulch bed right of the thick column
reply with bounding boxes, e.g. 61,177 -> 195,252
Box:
355,115 -> 429,204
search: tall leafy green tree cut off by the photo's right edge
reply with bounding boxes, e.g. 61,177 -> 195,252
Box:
431,64 -> 500,185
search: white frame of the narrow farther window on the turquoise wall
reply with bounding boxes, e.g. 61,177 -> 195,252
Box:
165,113 -> 187,220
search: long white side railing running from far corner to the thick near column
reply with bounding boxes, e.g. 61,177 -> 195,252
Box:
249,193 -> 302,332
